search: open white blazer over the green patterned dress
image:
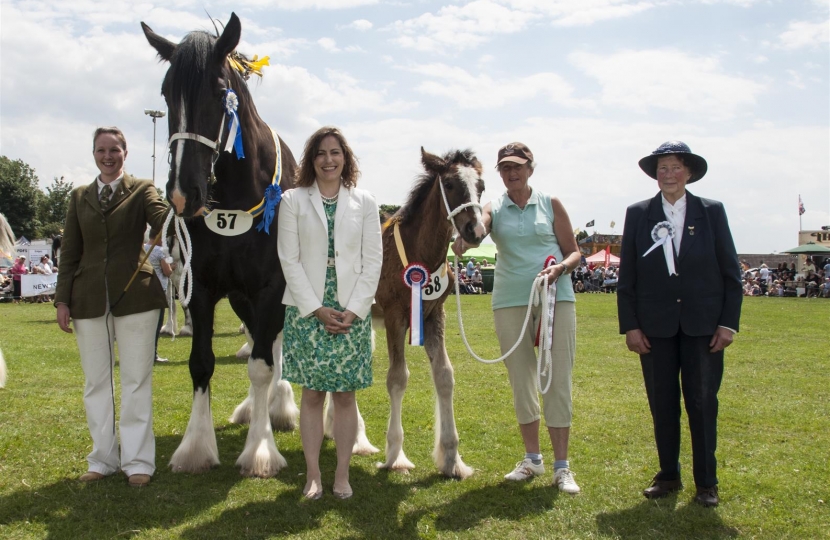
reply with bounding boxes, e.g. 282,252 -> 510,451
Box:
277,182 -> 383,319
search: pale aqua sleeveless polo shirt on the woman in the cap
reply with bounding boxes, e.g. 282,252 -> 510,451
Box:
490,188 -> 576,309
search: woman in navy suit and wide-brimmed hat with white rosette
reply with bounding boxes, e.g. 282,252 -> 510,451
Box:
617,141 -> 743,506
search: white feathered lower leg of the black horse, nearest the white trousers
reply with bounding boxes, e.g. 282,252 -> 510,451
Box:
170,390 -> 219,473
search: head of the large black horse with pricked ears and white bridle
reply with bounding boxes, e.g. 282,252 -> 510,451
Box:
141,13 -> 244,217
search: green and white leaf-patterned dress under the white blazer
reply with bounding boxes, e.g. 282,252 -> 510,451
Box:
282,203 -> 372,392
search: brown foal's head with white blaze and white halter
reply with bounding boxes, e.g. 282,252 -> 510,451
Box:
421,147 -> 485,244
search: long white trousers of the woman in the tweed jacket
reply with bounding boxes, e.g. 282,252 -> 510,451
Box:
73,309 -> 159,476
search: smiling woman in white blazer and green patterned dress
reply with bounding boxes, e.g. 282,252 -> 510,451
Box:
278,127 -> 383,499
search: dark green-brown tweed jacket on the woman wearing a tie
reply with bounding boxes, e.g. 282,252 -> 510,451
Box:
55,174 -> 172,319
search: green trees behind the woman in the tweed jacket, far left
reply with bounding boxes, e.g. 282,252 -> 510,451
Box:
0,156 -> 72,240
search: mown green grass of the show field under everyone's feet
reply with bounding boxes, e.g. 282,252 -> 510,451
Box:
0,295 -> 830,539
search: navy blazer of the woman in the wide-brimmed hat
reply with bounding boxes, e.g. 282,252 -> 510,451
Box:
617,191 -> 743,338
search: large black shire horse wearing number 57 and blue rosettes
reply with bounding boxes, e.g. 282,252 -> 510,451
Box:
141,14 -> 298,477
